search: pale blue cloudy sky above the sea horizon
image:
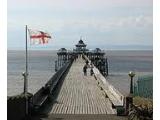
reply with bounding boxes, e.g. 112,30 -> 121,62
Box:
7,0 -> 153,50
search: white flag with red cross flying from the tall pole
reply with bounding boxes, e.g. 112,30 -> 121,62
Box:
28,29 -> 51,45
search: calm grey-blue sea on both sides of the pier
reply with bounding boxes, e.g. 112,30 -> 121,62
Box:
7,50 -> 153,96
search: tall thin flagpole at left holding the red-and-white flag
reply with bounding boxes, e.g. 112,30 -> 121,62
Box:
24,25 -> 28,94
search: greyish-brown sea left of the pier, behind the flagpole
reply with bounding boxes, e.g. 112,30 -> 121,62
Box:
7,51 -> 57,96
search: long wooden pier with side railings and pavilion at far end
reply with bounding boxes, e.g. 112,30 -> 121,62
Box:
8,40 -> 129,120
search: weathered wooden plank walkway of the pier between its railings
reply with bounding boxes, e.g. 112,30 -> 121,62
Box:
49,58 -> 116,114
